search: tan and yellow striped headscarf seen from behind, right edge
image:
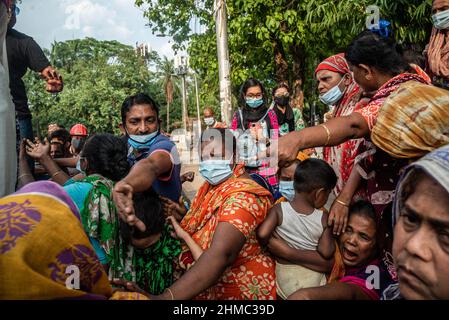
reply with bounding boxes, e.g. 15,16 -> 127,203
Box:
371,81 -> 449,159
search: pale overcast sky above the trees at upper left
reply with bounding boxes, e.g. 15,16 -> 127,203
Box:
15,0 -> 173,57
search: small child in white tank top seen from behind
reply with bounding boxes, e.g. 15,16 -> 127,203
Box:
257,159 -> 337,299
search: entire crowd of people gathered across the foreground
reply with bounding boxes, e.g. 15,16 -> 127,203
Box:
0,0 -> 449,300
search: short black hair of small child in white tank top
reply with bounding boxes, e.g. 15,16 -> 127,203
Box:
294,158 -> 337,193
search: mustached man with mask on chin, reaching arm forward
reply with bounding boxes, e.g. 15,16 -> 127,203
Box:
114,93 -> 182,231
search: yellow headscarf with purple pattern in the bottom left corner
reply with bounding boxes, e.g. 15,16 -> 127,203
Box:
0,181 -> 112,300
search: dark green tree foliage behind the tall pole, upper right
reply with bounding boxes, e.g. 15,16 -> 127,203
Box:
135,0 -> 431,122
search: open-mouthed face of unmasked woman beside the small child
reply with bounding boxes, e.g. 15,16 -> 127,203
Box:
340,213 -> 376,267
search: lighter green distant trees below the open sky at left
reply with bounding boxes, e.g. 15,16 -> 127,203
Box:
24,38 -> 201,134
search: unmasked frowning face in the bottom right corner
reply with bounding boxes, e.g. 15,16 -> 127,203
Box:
393,175 -> 449,299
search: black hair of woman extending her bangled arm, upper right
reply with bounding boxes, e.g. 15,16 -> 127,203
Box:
345,30 -> 410,76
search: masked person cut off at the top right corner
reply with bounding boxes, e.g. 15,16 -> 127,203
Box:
424,0 -> 449,90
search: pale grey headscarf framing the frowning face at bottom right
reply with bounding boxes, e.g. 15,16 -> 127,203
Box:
393,145 -> 449,226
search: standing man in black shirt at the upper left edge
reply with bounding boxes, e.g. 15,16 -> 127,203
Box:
6,0 -> 63,139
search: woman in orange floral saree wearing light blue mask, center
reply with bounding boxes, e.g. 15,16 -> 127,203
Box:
134,129 -> 276,300
